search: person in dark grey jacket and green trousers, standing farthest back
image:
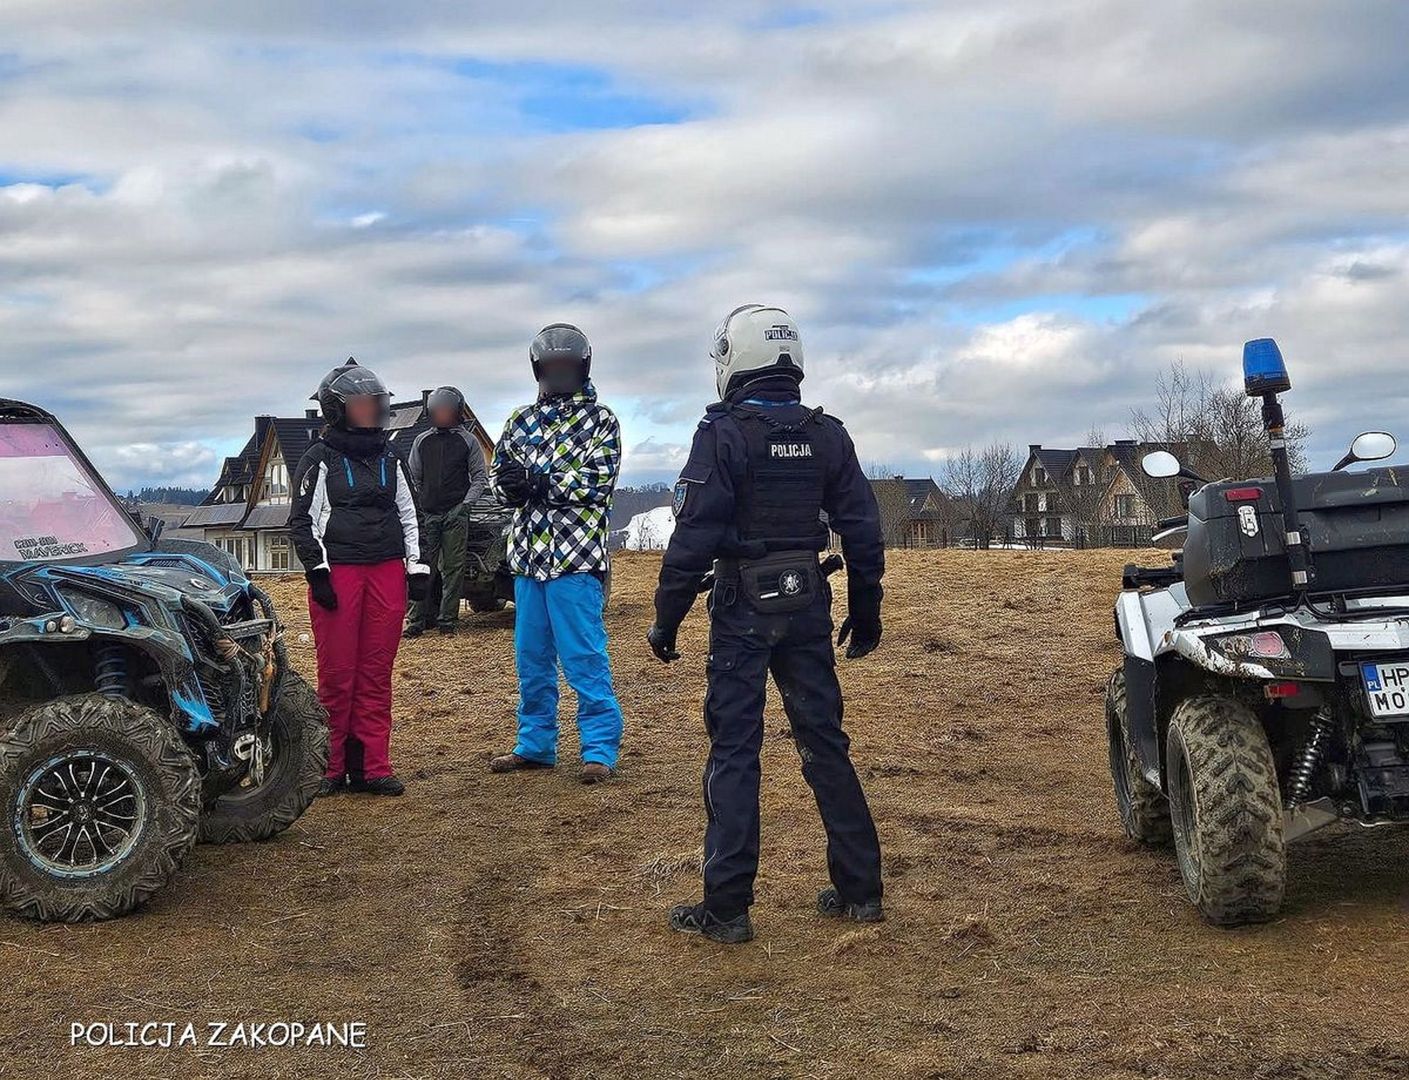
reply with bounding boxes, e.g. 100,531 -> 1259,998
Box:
406,386 -> 489,638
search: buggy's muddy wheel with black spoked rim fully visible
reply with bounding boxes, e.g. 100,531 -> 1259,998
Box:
0,694 -> 200,922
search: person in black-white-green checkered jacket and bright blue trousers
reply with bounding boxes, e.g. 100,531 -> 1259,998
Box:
489,322 -> 623,784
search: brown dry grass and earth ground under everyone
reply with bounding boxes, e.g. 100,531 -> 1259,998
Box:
0,552 -> 1409,1080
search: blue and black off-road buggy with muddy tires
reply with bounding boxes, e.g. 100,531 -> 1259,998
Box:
0,398 -> 328,922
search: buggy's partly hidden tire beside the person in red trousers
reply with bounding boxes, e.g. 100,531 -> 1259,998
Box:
200,672 -> 328,843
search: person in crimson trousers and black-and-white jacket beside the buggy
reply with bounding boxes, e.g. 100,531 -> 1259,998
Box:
289,358 -> 430,796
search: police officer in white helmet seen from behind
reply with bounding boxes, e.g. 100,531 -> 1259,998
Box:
647,304 -> 885,943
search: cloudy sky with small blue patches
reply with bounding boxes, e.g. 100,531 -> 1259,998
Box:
0,0 -> 1409,487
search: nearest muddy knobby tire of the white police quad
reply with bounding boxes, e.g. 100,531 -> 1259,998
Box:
1165,694 -> 1286,927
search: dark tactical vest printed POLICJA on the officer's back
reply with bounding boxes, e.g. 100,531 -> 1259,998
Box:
730,407 -> 827,551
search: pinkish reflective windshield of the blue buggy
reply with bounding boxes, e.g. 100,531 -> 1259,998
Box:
0,424 -> 142,562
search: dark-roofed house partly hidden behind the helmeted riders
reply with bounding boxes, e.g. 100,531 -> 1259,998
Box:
180,390 -> 495,573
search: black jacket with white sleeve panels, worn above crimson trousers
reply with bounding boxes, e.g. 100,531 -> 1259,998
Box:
289,429 -> 430,574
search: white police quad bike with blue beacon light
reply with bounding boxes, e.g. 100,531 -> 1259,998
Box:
1106,338 -> 1409,925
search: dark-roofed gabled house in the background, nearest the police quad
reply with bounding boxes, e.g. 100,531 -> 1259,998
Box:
1009,439 -> 1208,546
